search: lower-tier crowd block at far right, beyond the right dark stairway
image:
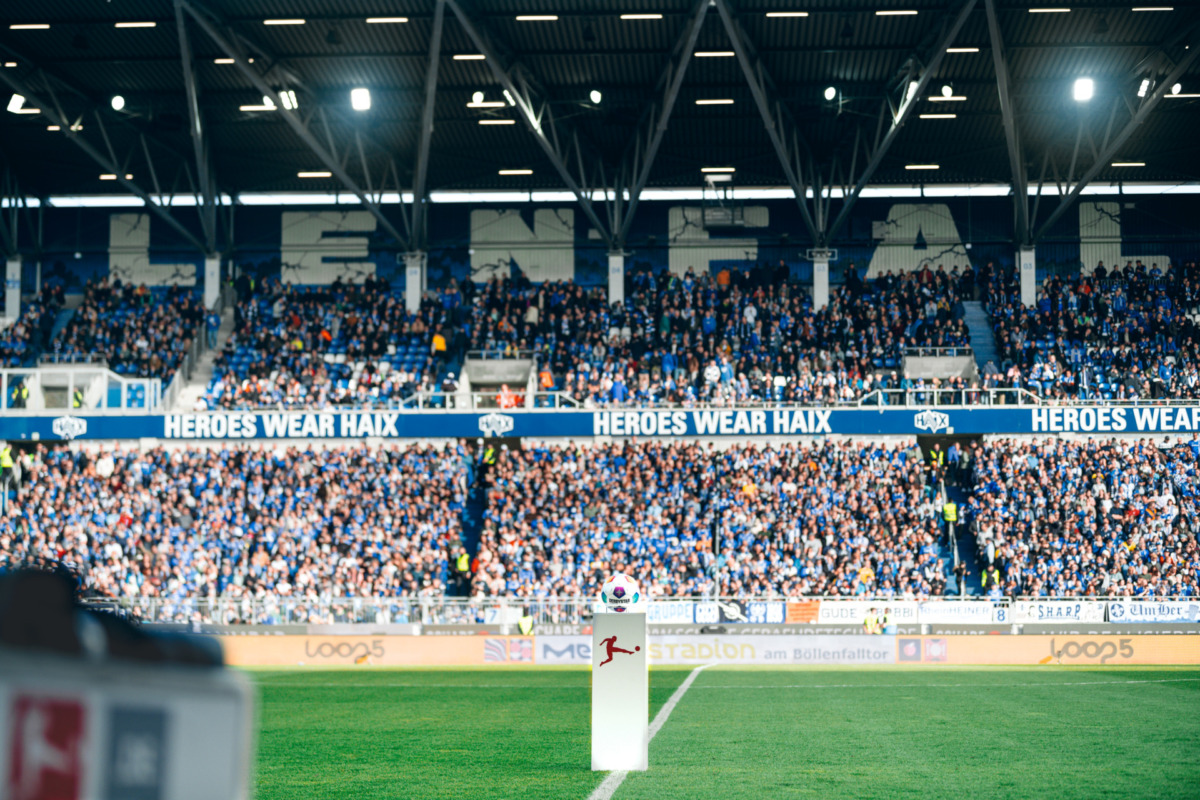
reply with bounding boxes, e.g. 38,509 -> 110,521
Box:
965,438 -> 1200,599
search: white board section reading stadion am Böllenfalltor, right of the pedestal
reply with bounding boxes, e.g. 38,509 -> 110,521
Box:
650,634 -> 895,664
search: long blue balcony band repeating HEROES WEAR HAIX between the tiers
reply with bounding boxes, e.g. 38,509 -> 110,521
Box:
11,405 -> 1200,441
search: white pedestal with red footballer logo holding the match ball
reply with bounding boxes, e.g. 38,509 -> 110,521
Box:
592,613 -> 650,770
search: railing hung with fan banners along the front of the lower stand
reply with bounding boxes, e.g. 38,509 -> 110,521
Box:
87,597 -> 1200,630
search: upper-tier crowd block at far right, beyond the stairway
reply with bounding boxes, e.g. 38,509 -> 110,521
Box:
984,261 -> 1200,401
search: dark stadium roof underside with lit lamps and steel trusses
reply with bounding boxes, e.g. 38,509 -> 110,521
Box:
0,0 -> 1200,247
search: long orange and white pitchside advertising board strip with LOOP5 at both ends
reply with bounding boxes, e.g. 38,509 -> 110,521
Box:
211,634 -> 1200,667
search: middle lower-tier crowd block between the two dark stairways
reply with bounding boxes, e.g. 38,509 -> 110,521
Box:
473,441 -> 946,600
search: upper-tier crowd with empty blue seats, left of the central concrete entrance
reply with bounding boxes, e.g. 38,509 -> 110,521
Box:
205,276 -> 449,409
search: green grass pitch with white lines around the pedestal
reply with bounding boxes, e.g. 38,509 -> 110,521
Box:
252,667 -> 1200,800
